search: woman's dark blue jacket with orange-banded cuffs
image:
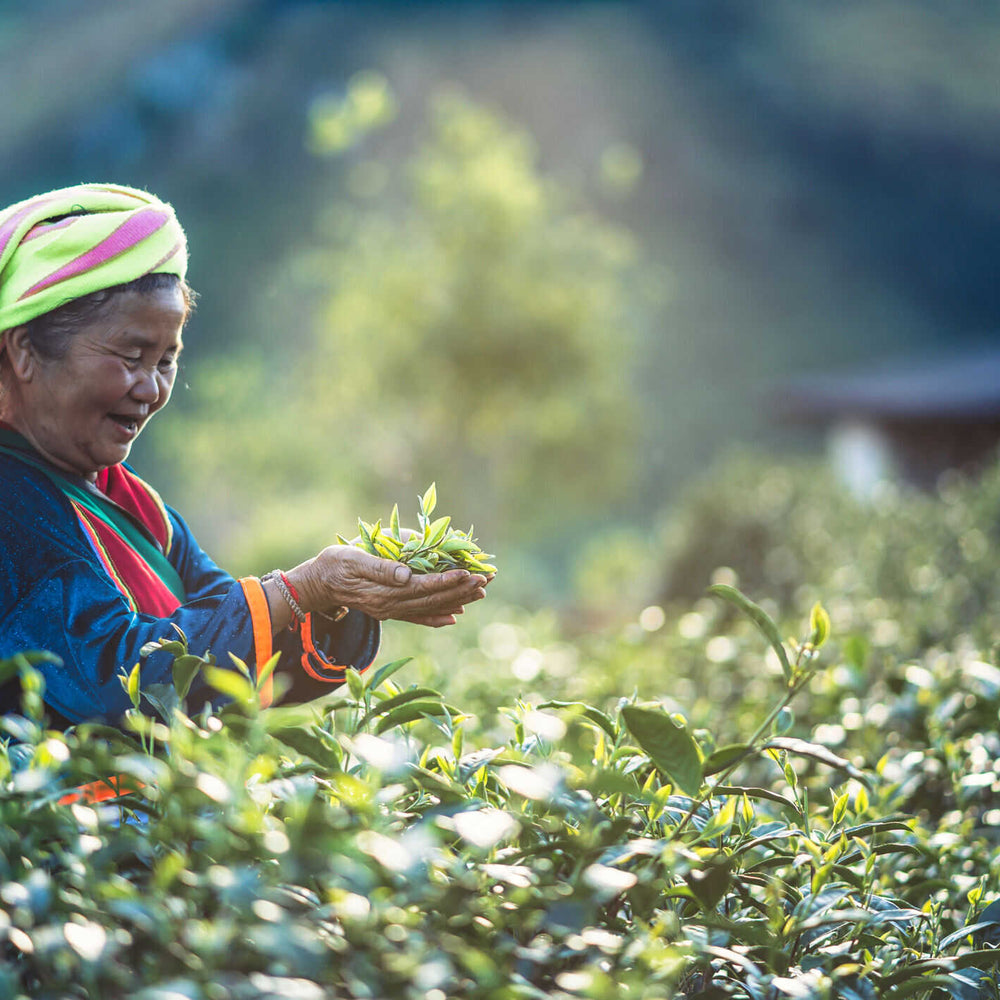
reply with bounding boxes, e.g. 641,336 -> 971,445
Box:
0,453 -> 380,728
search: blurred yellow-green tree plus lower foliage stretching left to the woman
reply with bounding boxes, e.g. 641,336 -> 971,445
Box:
161,86 -> 638,596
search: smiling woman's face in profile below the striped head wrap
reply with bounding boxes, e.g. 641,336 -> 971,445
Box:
11,288 -> 187,479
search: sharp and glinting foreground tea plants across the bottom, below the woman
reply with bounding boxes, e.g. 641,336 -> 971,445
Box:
0,587 -> 1000,1000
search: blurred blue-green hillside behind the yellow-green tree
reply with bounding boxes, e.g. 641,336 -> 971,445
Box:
0,0 -> 1000,600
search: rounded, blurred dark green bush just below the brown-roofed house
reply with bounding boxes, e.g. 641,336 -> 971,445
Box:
660,453 -> 1000,656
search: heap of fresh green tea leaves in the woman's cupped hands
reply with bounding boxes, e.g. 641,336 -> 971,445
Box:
337,483 -> 497,576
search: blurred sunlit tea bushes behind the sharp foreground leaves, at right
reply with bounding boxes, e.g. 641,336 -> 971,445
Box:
385,452 -> 1000,816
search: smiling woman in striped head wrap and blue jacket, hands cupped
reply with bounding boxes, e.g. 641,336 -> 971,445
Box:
0,184 -> 487,727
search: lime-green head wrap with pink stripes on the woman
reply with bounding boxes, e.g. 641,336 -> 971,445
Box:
0,184 -> 187,332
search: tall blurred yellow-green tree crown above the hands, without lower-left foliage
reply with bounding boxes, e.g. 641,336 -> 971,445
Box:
310,95 -> 635,533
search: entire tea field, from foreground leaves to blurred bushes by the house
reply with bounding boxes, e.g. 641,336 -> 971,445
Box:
0,456 -> 1000,1000
